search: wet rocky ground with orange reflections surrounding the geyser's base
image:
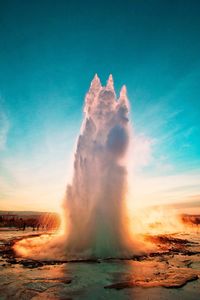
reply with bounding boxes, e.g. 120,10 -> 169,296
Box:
0,230 -> 200,300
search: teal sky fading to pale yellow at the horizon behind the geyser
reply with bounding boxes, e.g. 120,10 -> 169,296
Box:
0,0 -> 200,210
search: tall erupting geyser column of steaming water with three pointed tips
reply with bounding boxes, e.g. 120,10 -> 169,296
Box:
65,75 -> 133,257
